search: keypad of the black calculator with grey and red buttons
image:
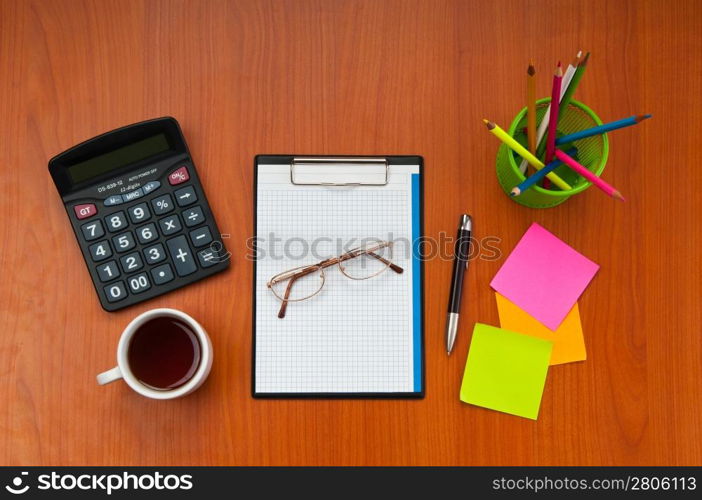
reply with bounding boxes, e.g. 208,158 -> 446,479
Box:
72,164 -> 226,310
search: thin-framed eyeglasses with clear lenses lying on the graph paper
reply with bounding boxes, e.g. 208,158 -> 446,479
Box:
266,241 -> 403,318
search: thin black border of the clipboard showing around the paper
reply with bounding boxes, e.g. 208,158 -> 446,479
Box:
251,154 -> 426,399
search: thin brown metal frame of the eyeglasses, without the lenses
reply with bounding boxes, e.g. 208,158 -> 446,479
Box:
266,241 -> 404,319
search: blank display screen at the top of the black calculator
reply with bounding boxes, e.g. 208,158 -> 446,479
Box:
68,134 -> 171,183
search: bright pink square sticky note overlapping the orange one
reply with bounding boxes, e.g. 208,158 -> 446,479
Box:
490,223 -> 600,330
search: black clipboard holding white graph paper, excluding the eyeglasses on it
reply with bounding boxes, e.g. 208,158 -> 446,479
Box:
254,155 -> 425,399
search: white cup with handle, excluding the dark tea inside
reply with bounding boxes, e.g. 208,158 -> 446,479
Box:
97,309 -> 212,399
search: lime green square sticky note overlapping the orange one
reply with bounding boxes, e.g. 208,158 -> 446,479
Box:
461,323 -> 553,420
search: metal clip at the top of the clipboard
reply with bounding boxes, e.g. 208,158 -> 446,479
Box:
290,157 -> 389,187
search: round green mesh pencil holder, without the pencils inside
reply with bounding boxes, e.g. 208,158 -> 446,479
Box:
497,97 -> 609,208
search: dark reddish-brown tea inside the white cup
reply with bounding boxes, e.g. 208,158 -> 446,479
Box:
127,317 -> 200,390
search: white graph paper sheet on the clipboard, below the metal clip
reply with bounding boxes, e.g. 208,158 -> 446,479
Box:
255,166 -> 421,394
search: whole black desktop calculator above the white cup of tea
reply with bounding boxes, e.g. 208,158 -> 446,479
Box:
49,117 -> 230,311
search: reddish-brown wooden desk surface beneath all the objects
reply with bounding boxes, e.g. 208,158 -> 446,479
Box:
0,0 -> 702,465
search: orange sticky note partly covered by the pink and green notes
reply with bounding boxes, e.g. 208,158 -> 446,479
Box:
495,292 -> 587,365
